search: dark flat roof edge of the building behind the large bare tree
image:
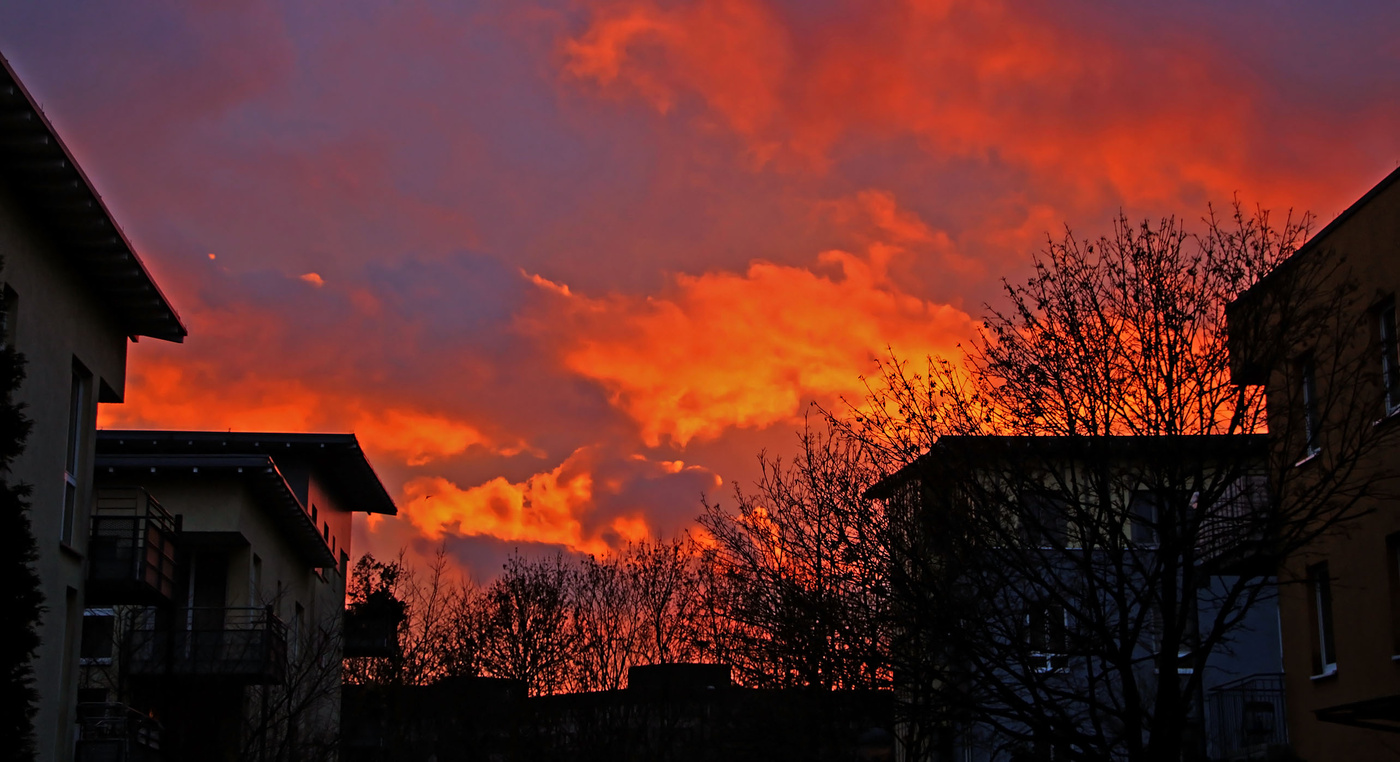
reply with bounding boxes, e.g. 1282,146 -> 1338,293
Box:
862,434 -> 1268,500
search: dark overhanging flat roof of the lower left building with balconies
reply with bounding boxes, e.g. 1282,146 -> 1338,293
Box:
97,429 -> 399,515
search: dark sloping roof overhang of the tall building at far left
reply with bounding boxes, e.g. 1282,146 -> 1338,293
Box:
0,56 -> 189,342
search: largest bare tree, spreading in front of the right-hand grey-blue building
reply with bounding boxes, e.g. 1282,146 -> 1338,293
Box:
832,205 -> 1389,761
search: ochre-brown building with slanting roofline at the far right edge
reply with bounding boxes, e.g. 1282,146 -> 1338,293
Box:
1229,169 -> 1400,759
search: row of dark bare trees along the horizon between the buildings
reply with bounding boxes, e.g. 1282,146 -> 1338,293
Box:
346,481 -> 889,695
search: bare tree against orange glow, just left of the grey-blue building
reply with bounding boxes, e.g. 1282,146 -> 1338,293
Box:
700,420 -> 889,689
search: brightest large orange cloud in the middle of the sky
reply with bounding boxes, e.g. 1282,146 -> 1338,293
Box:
532,193 -> 973,447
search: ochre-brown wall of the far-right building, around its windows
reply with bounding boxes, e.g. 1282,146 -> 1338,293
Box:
1268,182 -> 1400,759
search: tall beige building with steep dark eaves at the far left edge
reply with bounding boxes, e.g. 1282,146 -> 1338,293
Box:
0,50 -> 186,761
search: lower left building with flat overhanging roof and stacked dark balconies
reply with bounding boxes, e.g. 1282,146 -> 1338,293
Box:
77,430 -> 396,761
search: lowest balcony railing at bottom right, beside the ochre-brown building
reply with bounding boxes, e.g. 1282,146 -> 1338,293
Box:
1210,674 -> 1288,759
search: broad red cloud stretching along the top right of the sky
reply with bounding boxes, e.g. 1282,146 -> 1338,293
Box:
561,0 -> 1383,206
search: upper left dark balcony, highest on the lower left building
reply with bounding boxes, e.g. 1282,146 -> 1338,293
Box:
87,487 -> 176,607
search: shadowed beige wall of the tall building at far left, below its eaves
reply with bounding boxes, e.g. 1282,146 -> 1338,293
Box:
0,185 -> 126,761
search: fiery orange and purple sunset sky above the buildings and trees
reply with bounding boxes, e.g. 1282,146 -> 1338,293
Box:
0,0 -> 1400,577
